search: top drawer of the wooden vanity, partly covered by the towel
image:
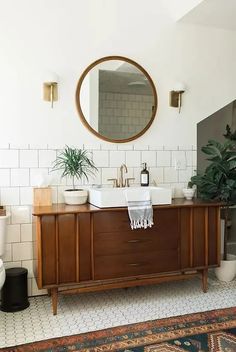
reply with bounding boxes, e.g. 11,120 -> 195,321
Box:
93,209 -> 179,234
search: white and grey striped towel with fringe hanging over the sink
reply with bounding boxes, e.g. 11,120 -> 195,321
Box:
125,188 -> 154,230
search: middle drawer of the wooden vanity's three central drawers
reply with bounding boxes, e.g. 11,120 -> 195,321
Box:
93,229 -> 179,256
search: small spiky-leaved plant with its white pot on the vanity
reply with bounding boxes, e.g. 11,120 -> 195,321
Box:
52,146 -> 97,204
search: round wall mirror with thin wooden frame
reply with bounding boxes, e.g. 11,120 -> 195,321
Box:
76,56 -> 157,143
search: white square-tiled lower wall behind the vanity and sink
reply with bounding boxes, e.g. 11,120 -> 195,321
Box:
0,142 -> 196,295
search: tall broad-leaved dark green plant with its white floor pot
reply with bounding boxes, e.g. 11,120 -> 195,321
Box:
191,140 -> 236,281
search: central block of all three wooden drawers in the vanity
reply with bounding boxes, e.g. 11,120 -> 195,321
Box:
93,209 -> 180,280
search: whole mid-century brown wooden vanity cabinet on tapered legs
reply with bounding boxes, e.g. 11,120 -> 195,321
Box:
33,200 -> 220,314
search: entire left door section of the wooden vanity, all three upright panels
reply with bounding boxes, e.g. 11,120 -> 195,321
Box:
37,213 -> 91,288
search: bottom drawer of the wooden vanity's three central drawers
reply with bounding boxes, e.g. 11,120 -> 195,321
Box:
94,249 -> 180,280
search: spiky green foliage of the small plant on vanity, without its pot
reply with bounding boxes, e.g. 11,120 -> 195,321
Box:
52,145 -> 98,190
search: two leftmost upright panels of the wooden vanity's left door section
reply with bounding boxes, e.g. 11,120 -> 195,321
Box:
38,214 -> 79,287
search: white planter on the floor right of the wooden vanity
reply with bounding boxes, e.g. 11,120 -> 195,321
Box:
215,254 -> 236,282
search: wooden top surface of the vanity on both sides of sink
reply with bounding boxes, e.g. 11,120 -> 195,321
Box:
32,198 -> 223,216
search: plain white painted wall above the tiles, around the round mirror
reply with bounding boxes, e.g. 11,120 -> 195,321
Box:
0,0 -> 236,145
